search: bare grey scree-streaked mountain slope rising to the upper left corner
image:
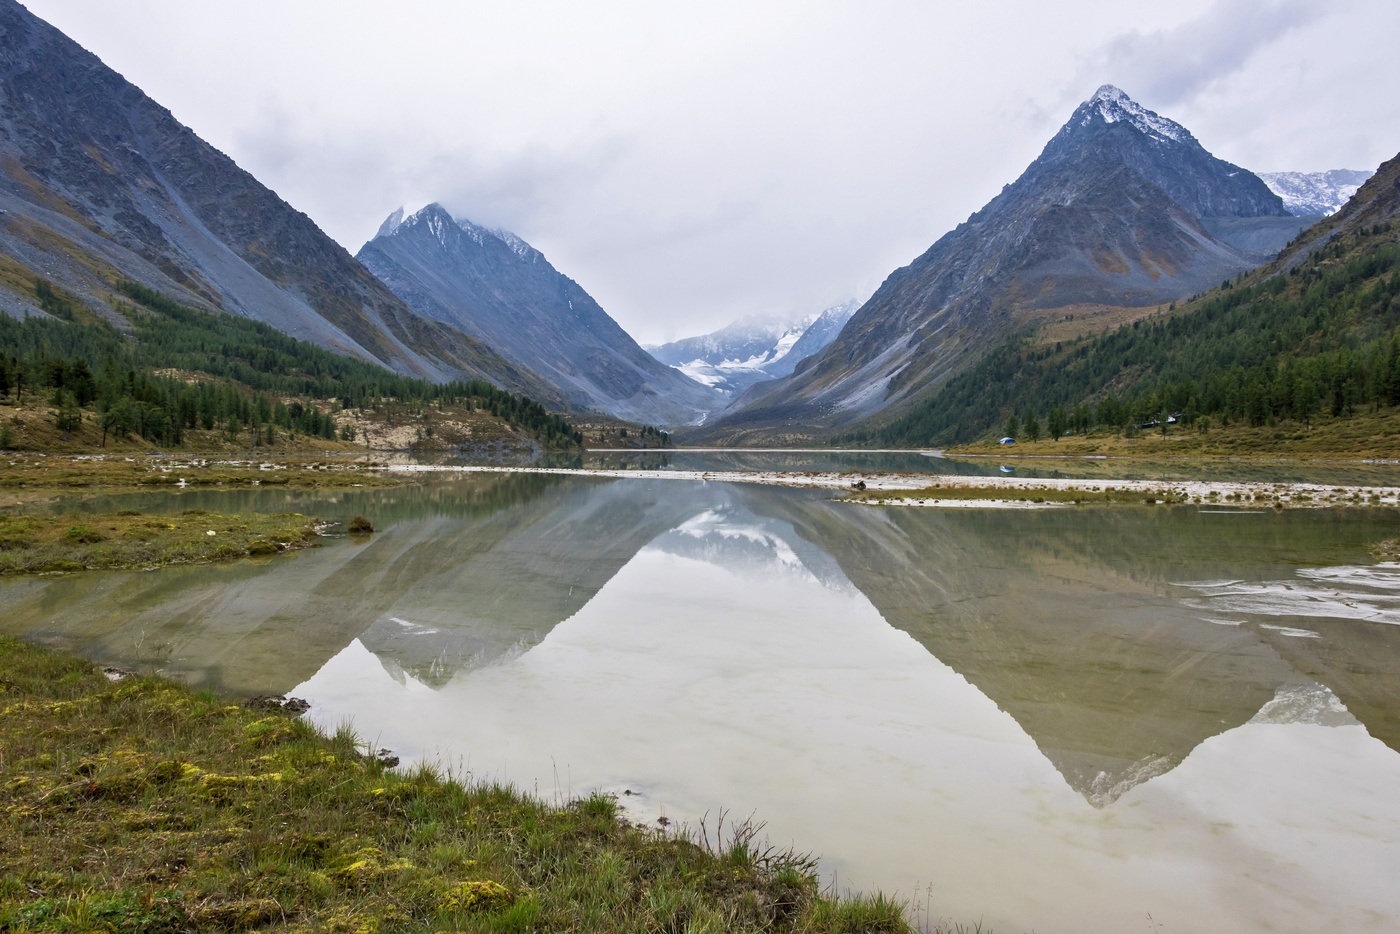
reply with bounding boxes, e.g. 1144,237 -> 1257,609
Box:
0,0 -> 549,398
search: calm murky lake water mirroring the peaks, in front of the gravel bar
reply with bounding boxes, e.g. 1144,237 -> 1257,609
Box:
0,475 -> 1400,934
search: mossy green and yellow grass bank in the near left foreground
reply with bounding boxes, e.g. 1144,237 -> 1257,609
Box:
0,640 -> 910,934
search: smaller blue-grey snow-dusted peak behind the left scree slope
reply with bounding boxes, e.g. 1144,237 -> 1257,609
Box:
356,204 -> 721,426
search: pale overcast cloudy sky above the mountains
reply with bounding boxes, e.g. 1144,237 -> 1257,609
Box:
25,0 -> 1400,343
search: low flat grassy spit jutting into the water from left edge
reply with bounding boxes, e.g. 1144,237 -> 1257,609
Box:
0,510 -> 318,574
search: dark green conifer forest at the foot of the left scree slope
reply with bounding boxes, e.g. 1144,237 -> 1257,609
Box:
0,280 -> 581,447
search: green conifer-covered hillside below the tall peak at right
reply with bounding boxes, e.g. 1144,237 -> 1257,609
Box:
868,161 -> 1400,445
